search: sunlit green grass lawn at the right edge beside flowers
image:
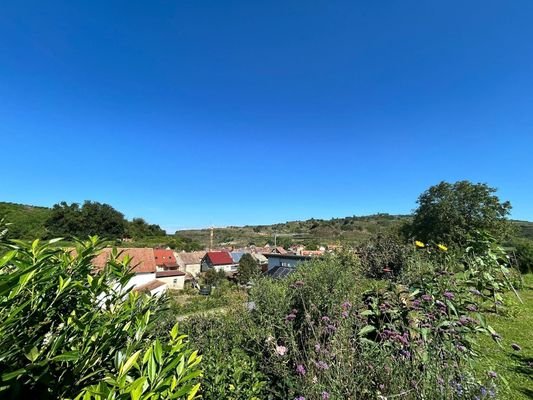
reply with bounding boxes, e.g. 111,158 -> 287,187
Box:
477,274 -> 533,400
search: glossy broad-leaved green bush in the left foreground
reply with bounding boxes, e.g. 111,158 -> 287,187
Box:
0,233 -> 201,399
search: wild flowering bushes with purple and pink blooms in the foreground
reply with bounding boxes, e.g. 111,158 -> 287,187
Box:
185,246 -> 516,400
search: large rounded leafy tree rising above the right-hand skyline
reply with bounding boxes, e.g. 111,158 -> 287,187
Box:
409,181 -> 511,247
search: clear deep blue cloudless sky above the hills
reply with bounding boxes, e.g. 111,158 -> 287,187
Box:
0,0 -> 533,231
